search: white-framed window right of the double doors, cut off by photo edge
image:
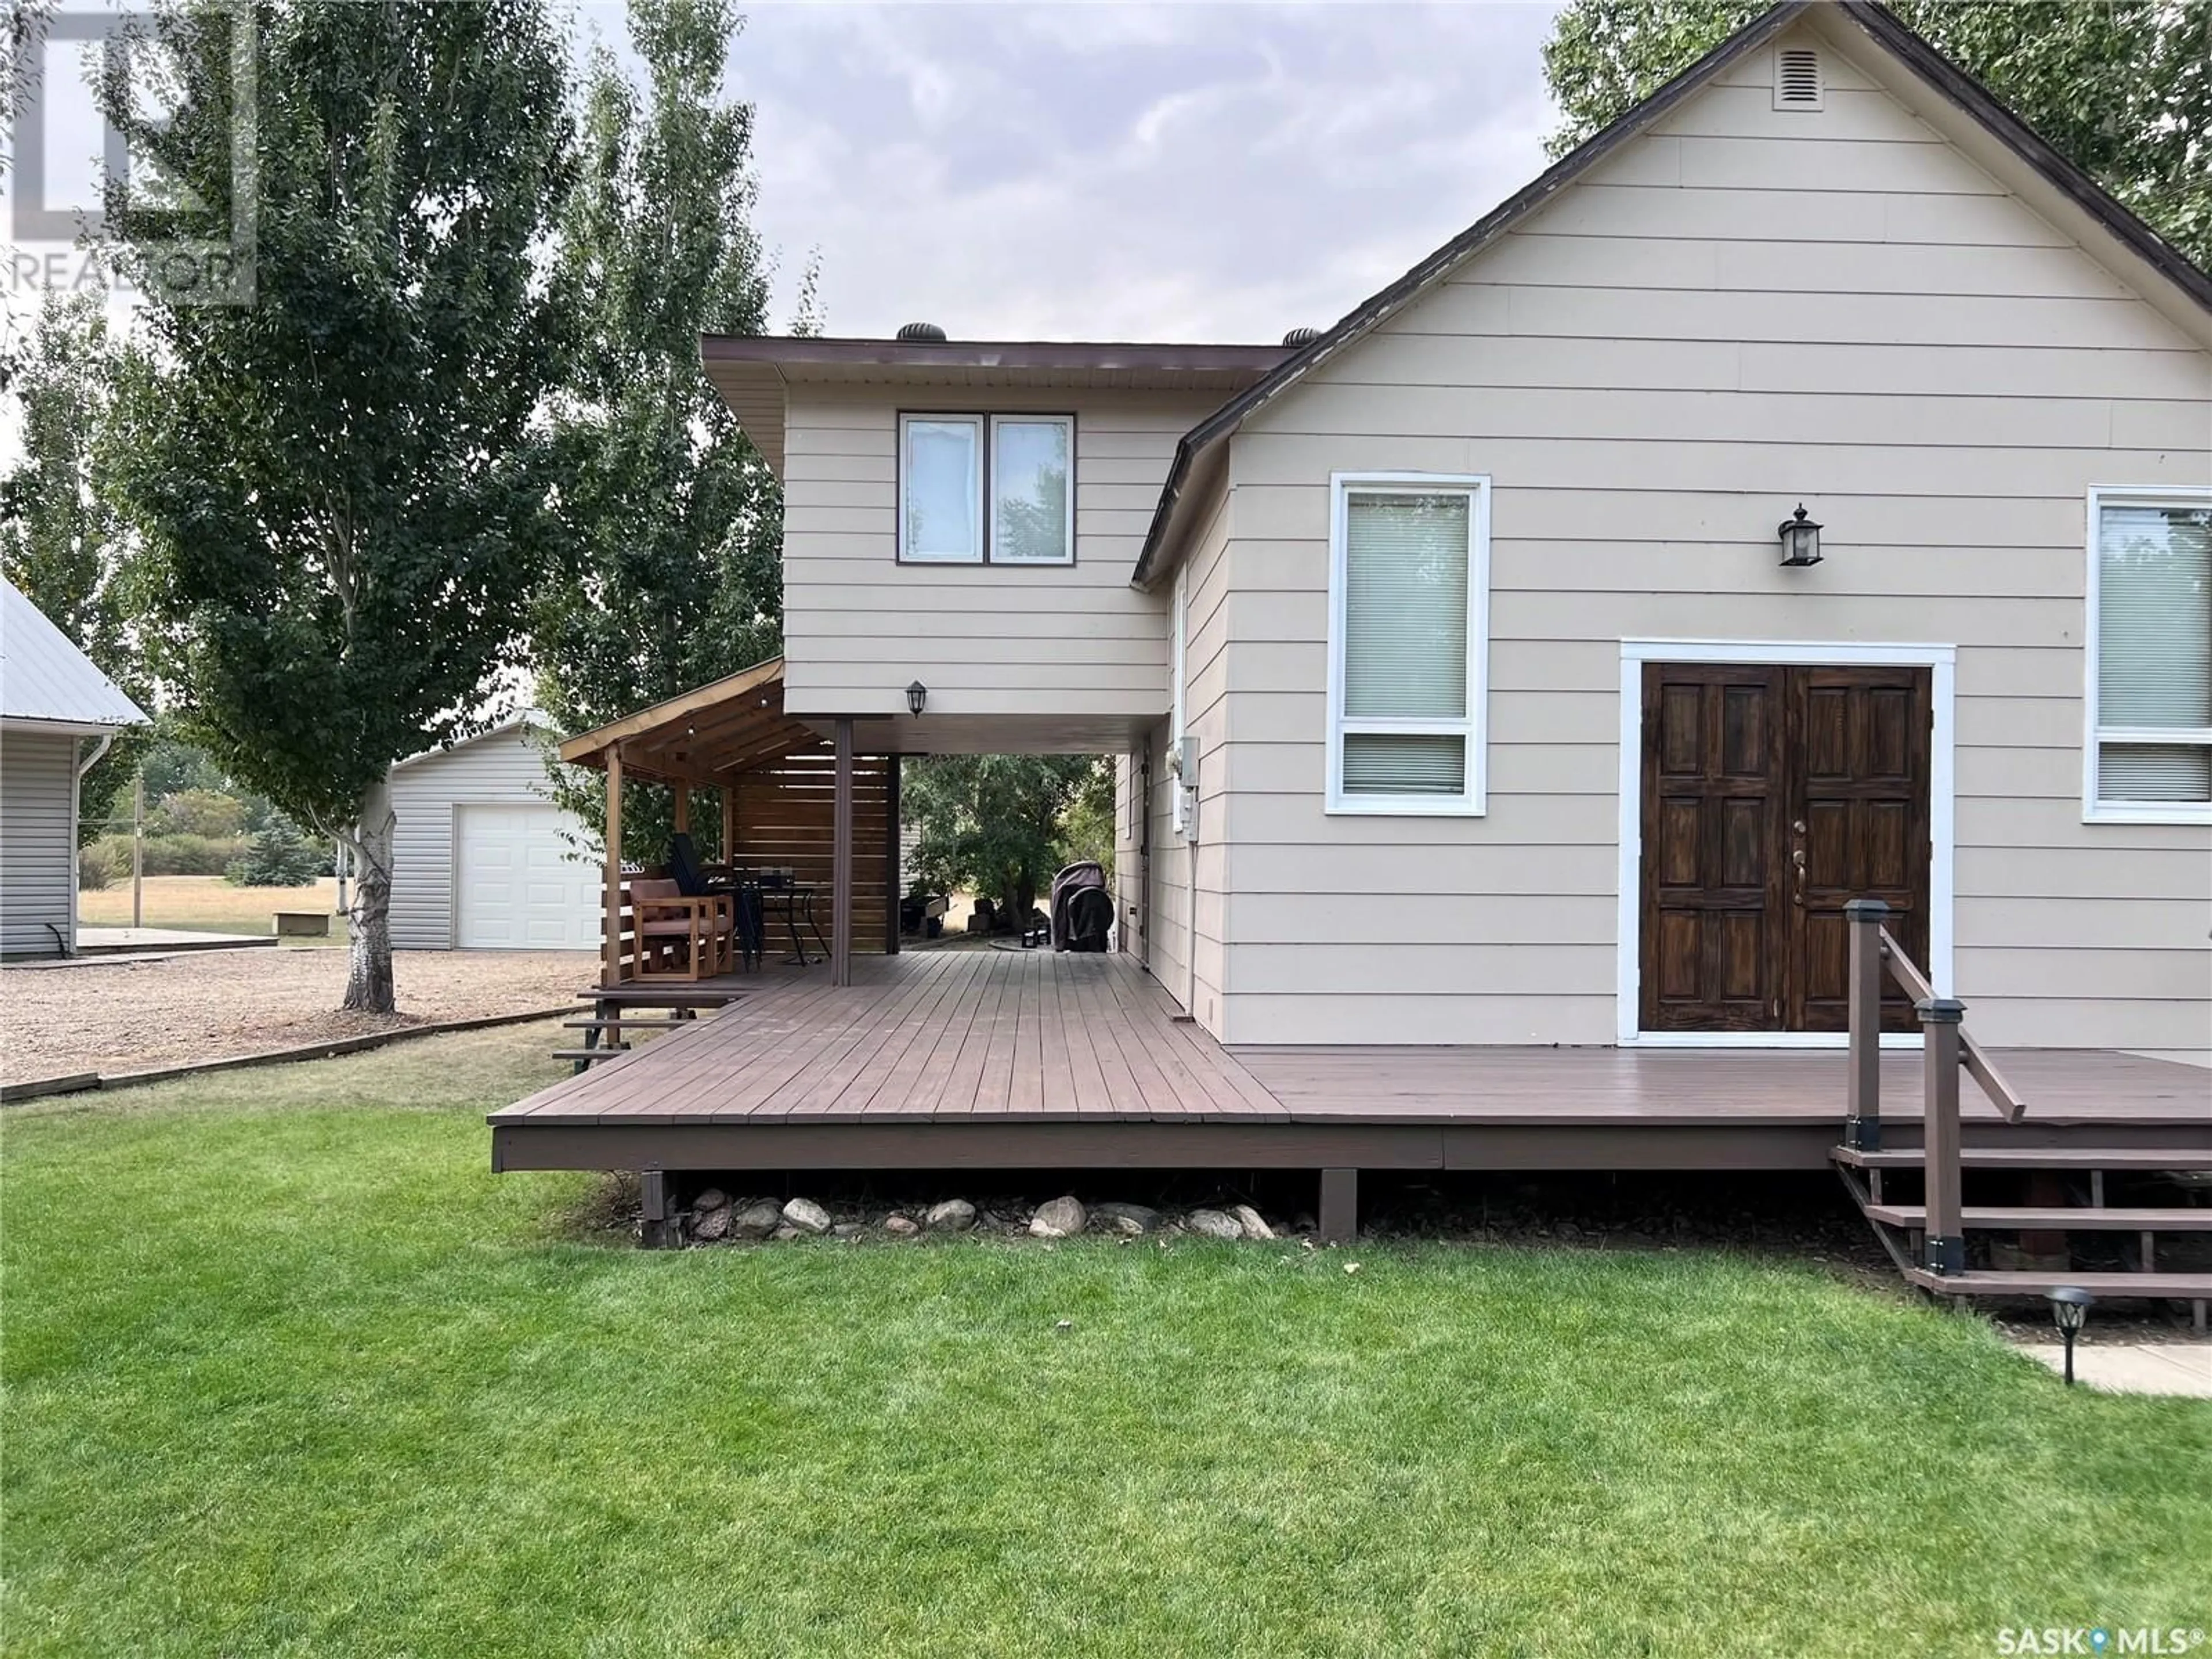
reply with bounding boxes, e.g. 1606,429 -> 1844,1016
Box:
2081,487 -> 2212,823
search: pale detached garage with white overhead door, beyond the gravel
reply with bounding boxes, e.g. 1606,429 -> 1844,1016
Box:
392,717 -> 600,951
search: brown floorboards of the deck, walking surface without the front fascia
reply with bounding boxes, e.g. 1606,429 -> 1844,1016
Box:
491,947 -> 2212,1143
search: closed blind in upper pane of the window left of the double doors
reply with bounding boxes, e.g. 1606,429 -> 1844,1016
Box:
1345,495 -> 1471,725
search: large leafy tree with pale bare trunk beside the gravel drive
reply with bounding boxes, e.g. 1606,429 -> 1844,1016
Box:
106,0 -> 571,1011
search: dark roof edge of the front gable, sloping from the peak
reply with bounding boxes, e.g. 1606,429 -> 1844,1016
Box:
1130,0 -> 2212,588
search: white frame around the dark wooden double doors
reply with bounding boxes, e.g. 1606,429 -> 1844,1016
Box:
1615,639 -> 1957,1048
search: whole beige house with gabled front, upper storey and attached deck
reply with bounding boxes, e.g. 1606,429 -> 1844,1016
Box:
493,0 -> 2212,1296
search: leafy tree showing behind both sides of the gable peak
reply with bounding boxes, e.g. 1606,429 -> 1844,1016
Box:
1544,0 -> 2212,266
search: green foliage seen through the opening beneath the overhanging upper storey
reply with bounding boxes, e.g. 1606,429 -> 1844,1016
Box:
900,754 -> 1113,922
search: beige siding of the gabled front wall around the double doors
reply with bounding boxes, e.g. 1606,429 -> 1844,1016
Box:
1212,22 -> 2212,1058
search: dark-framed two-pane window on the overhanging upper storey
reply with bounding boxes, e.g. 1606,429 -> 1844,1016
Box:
898,414 -> 1075,564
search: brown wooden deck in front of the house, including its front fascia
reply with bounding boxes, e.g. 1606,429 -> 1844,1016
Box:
491,949 -> 2212,1170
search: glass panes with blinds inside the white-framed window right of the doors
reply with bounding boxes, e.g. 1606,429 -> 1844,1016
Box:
2097,502 -> 2212,803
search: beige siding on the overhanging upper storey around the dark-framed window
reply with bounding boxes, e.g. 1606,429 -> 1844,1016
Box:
783,387 -> 1217,728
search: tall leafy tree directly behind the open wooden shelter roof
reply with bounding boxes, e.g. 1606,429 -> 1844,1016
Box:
533,0 -> 812,858
